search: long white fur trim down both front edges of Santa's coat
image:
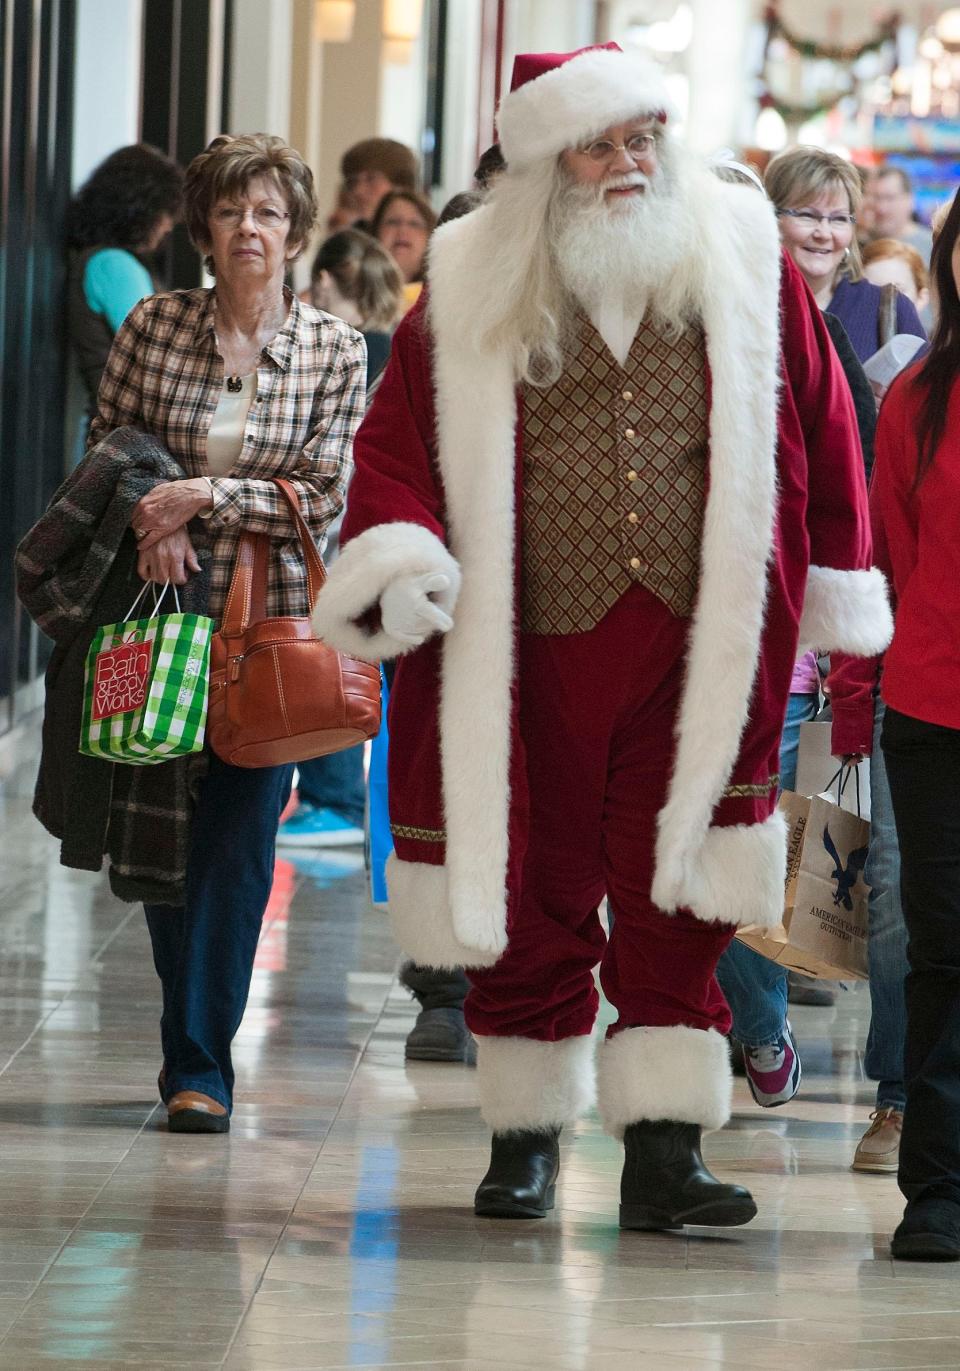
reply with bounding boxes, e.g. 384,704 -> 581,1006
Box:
429,176 -> 780,950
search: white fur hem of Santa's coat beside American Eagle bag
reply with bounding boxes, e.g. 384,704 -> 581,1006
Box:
651,810 -> 787,928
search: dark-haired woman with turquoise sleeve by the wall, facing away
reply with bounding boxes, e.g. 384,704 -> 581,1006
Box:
67,143 -> 184,411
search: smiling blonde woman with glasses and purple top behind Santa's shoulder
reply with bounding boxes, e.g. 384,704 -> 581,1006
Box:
764,147 -> 926,362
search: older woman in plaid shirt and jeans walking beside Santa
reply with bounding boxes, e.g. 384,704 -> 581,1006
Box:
91,134 -> 365,1132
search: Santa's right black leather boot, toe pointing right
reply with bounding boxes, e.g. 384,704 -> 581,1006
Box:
620,1119 -> 757,1230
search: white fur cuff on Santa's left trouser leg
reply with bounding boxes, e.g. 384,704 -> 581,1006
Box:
477,1034 -> 595,1132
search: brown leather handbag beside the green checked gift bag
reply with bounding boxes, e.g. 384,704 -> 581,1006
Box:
207,480 -> 380,766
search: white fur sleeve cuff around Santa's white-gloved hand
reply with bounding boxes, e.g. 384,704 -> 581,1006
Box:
313,522 -> 459,662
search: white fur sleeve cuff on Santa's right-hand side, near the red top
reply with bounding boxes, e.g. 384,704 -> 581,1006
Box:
798,566 -> 893,657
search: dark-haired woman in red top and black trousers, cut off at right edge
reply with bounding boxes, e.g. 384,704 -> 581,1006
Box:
871,197 -> 960,1261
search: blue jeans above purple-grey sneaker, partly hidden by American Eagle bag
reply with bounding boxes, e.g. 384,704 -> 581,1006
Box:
717,695 -> 820,1047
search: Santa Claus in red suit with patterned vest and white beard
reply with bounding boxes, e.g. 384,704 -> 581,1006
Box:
315,45 -> 891,1228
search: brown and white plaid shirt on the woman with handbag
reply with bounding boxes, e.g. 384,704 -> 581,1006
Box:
88,288 -> 366,618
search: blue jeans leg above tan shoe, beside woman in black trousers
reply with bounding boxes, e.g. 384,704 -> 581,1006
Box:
864,699 -> 908,1109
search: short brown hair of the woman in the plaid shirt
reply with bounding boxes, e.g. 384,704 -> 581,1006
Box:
184,133 -> 318,267
